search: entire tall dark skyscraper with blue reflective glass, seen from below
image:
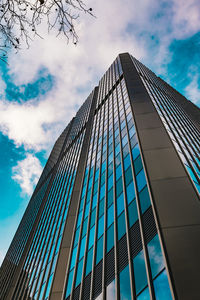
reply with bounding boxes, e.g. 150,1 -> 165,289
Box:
0,53 -> 200,300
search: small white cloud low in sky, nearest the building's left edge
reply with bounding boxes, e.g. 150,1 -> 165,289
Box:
12,153 -> 42,195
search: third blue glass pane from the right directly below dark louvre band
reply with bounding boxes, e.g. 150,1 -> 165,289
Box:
119,266 -> 131,300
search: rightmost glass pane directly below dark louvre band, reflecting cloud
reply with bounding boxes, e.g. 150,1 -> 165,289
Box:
147,235 -> 164,278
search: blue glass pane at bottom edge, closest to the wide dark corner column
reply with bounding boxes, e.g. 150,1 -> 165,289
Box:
154,270 -> 172,300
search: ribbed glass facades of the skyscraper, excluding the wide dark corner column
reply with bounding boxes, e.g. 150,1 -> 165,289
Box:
0,56 -> 200,300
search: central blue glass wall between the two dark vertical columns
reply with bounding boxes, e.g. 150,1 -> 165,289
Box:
65,59 -> 172,300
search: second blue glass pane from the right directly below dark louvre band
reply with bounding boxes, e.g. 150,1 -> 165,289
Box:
133,250 -> 147,294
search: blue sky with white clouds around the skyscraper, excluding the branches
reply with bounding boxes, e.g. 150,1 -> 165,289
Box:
0,0 -> 200,263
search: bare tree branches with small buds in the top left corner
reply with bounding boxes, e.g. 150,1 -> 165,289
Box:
0,0 -> 93,62
